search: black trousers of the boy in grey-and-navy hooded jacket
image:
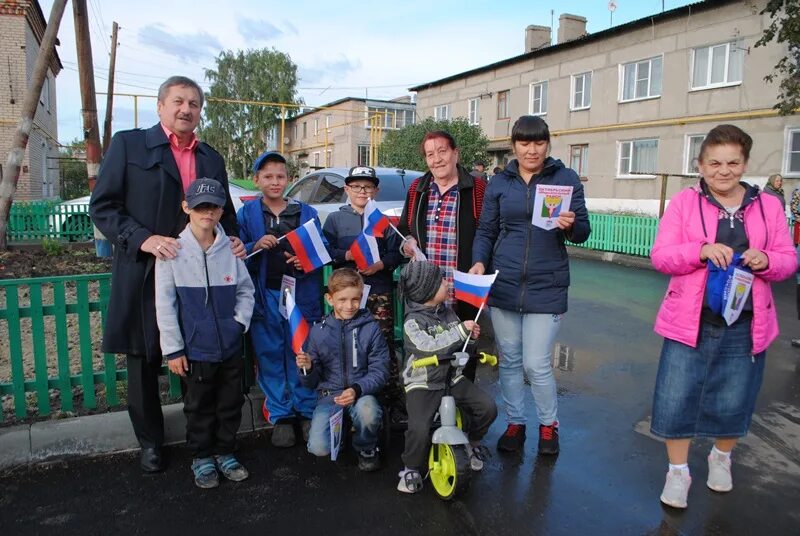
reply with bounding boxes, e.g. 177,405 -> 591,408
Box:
183,356 -> 244,458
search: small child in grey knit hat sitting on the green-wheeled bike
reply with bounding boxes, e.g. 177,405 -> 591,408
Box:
397,261 -> 497,493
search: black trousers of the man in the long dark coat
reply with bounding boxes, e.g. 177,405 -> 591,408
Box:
127,354 -> 164,448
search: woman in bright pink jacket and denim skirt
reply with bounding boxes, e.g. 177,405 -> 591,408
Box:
650,125 -> 797,508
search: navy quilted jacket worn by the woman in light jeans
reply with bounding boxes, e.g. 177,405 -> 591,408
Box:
472,157 -> 591,314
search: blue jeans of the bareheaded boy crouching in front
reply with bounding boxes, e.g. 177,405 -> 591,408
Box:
308,393 -> 383,456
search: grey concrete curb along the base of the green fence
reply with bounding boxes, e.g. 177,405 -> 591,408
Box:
0,390 -> 271,471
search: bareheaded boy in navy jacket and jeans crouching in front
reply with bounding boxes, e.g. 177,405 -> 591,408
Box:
296,268 -> 389,471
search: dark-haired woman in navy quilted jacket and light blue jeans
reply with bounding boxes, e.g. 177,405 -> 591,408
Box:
470,115 -> 591,454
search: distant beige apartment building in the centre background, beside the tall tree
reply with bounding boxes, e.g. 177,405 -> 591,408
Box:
277,96 -> 416,175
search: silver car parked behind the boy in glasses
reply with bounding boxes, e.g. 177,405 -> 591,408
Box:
286,167 -> 423,225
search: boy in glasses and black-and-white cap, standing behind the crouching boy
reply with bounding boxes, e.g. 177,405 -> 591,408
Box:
322,166 -> 405,422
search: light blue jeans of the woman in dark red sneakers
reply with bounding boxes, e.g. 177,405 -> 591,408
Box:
491,307 -> 561,425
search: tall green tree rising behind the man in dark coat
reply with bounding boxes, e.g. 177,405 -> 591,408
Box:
199,48 -> 302,178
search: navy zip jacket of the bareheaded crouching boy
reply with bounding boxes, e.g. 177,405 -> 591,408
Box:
298,309 -> 389,397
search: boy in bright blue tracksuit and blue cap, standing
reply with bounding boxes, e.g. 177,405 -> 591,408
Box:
236,151 -> 327,447
